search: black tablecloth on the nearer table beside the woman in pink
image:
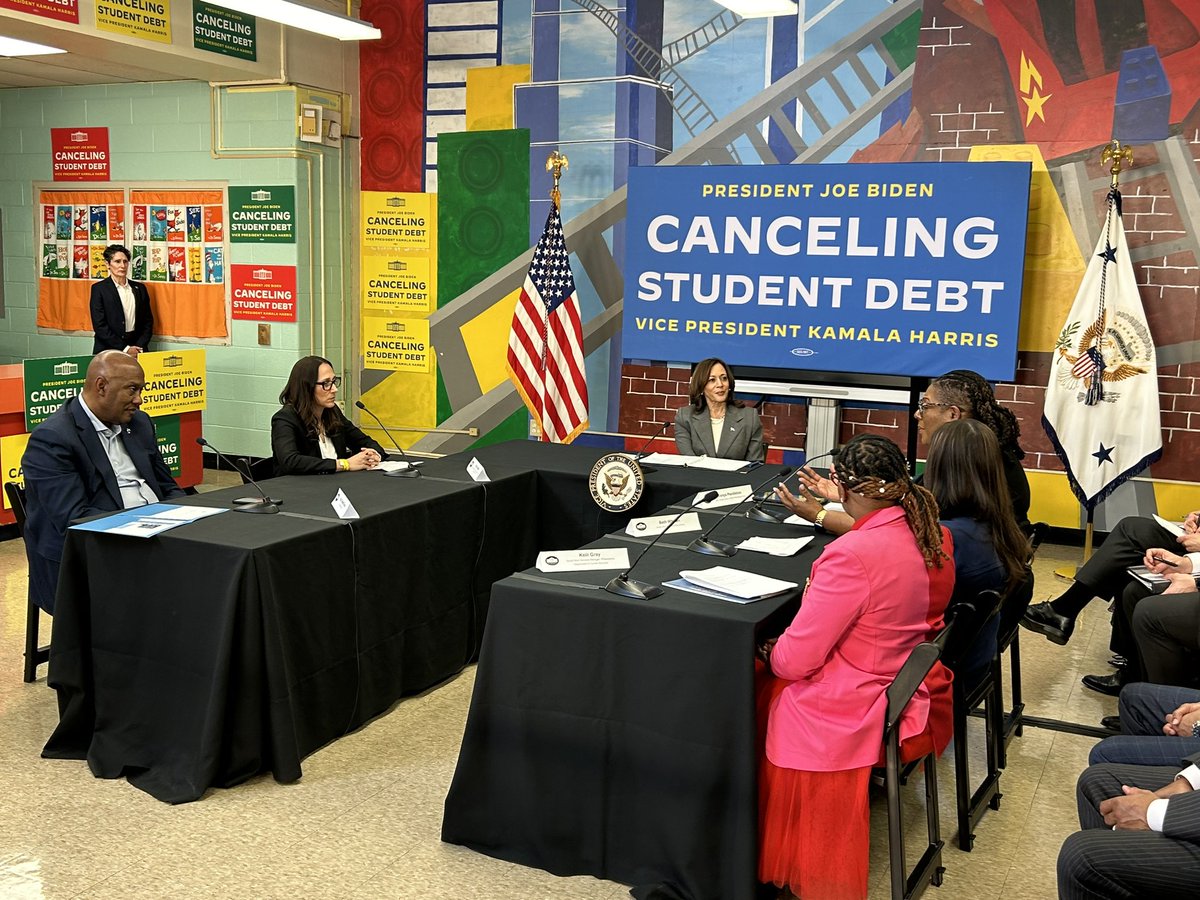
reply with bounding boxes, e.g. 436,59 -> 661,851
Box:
443,514 -> 827,900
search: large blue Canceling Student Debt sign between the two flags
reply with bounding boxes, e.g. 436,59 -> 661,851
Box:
622,162 -> 1030,379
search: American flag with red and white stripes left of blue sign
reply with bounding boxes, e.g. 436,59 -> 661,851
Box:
508,204 -> 588,444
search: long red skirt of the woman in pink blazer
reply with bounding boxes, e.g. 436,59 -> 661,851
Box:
756,662 -> 871,900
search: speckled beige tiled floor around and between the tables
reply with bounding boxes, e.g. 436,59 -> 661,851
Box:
0,494 -> 1116,900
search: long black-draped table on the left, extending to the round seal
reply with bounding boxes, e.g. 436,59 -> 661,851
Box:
43,442 -> 763,803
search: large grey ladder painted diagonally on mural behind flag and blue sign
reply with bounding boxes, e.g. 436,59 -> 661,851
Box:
412,0 -> 922,454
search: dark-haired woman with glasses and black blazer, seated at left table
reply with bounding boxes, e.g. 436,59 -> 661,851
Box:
271,356 -> 388,475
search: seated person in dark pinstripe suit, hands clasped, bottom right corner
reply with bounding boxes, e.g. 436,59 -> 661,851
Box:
1058,754 -> 1200,900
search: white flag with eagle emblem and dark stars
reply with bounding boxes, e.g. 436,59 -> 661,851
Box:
1042,188 -> 1163,510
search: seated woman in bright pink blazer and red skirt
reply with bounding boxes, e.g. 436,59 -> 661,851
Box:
758,434 -> 954,900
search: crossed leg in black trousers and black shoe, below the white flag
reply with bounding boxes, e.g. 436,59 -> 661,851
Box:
1021,516 -> 1178,643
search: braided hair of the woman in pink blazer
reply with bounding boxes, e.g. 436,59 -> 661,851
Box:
836,434 -> 949,569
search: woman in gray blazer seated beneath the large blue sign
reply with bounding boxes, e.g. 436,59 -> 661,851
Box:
676,358 -> 766,462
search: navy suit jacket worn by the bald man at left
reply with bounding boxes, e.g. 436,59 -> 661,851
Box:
20,397 -> 184,613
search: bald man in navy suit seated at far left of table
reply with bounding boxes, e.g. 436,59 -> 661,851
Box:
20,350 -> 184,613
